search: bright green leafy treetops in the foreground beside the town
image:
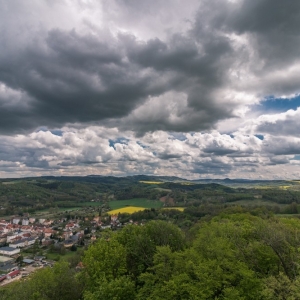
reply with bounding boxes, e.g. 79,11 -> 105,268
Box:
0,208 -> 300,300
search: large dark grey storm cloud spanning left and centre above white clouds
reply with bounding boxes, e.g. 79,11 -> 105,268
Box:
0,0 -> 232,133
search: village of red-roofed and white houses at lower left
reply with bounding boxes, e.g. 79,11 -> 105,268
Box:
0,215 -> 124,286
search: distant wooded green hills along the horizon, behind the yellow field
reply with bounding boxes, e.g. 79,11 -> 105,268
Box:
0,175 -> 300,217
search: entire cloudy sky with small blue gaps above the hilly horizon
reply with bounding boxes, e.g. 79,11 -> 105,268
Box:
0,0 -> 300,180
